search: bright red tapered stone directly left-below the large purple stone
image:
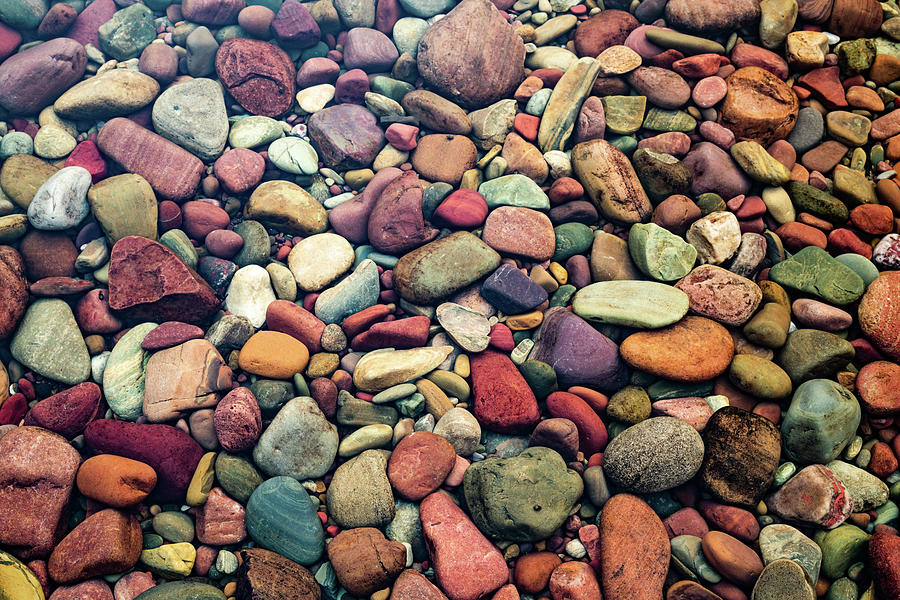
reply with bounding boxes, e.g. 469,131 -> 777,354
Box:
469,350 -> 541,433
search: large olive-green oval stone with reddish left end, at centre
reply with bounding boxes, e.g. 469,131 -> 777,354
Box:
394,230 -> 500,304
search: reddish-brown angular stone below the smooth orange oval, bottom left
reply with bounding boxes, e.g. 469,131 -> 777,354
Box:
47,508 -> 143,583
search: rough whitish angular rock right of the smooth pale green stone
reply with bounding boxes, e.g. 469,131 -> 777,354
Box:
628,223 -> 697,281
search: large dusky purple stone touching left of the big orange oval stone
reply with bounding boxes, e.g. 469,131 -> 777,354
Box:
528,306 -> 627,391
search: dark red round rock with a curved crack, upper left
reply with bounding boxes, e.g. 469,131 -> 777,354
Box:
216,38 -> 296,117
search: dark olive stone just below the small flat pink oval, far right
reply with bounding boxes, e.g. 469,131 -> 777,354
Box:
778,329 -> 856,383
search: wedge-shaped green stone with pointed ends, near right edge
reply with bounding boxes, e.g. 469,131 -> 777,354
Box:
769,246 -> 865,306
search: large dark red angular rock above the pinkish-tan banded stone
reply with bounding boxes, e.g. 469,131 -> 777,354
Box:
109,236 -> 219,323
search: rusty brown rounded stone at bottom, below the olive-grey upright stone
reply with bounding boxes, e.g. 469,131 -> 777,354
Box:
328,527 -> 406,596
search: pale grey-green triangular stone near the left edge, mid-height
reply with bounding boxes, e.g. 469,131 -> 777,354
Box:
9,298 -> 91,385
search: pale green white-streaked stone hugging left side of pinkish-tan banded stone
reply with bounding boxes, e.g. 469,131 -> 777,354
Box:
103,323 -> 157,420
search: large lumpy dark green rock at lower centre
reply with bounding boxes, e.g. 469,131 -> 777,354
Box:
463,446 -> 584,542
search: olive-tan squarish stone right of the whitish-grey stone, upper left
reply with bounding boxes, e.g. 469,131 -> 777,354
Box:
88,173 -> 159,245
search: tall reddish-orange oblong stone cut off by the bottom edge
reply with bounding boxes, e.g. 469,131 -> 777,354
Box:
600,494 -> 671,600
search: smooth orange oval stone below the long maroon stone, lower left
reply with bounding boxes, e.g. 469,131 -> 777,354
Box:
75,454 -> 156,508
